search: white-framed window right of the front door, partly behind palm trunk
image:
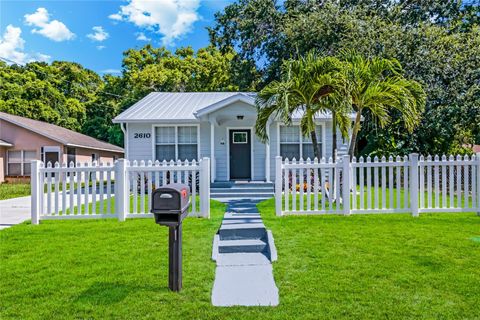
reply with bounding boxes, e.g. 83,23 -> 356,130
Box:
280,125 -> 323,160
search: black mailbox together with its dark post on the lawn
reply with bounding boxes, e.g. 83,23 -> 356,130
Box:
151,183 -> 190,291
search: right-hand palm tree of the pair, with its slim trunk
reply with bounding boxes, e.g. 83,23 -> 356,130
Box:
343,51 -> 426,156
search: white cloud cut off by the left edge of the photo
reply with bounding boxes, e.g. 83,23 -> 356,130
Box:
0,24 -> 51,64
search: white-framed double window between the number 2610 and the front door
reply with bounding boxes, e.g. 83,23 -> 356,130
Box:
155,126 -> 198,161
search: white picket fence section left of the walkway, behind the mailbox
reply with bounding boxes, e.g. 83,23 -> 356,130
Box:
31,158 -> 210,224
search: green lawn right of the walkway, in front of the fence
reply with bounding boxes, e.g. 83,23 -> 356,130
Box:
259,199 -> 480,319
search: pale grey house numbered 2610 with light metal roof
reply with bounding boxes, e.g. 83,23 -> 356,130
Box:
113,92 -> 347,181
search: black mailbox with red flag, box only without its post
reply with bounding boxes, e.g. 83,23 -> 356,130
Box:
151,183 -> 190,227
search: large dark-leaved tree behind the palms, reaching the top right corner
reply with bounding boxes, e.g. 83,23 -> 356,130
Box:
210,0 -> 480,154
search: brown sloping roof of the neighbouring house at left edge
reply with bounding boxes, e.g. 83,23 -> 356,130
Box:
0,112 -> 123,153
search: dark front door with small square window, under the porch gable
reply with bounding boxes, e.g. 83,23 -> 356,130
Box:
229,129 -> 252,180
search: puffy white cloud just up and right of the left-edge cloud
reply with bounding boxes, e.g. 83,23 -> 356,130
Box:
24,8 -> 75,42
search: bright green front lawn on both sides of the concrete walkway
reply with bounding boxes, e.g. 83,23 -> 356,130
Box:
0,199 -> 480,319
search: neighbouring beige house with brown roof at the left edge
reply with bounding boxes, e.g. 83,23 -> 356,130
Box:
0,112 -> 123,182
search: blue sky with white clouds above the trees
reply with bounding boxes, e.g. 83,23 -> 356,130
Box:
0,0 -> 233,74
